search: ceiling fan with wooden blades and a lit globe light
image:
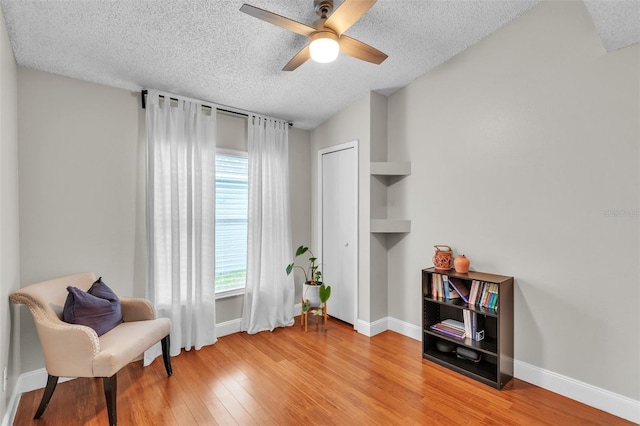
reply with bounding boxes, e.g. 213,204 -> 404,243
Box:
240,0 -> 387,71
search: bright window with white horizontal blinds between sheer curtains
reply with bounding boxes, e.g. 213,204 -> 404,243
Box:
216,149 -> 249,297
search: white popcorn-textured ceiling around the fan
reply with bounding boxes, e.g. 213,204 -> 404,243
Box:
0,0 -> 640,129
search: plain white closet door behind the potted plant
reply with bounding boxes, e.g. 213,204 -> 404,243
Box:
320,146 -> 358,324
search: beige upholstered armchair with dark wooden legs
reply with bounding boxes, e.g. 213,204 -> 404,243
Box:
9,273 -> 172,425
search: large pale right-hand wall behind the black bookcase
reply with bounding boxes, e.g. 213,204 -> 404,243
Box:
388,1 -> 640,401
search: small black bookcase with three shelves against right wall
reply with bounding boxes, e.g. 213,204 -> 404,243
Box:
422,268 -> 513,389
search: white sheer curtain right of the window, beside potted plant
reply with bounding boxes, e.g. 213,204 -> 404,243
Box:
242,116 -> 294,334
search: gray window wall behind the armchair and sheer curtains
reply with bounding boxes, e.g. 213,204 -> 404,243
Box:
18,68 -> 310,372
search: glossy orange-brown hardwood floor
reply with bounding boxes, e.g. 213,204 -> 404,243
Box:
14,317 -> 632,426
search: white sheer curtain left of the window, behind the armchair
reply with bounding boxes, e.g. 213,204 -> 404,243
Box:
144,91 -> 216,365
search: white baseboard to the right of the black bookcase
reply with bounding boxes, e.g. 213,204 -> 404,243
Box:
514,360 -> 640,424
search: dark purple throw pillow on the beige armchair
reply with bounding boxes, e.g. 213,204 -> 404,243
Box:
62,277 -> 122,336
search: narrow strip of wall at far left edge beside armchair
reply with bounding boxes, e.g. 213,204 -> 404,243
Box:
0,5 -> 20,420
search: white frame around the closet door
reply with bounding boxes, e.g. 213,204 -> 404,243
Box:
316,139 -> 360,331
